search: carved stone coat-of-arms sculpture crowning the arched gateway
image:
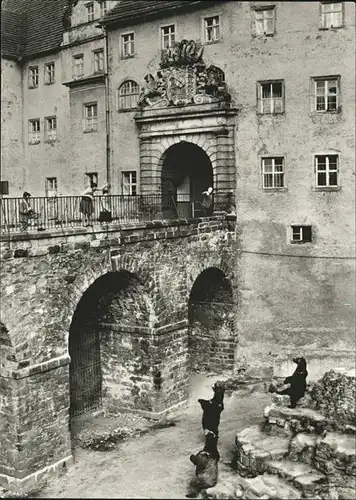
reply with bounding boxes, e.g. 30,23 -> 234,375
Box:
138,40 -> 231,108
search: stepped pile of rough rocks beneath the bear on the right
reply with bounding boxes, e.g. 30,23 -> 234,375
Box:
204,370 -> 356,500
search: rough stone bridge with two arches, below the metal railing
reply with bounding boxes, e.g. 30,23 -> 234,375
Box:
0,215 -> 237,486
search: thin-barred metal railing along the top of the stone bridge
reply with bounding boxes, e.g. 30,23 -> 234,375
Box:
0,194 -> 228,233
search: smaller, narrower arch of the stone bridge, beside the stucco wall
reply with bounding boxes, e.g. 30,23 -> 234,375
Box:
188,268 -> 235,371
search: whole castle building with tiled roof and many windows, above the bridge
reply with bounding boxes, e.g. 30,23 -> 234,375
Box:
1,0 -> 355,376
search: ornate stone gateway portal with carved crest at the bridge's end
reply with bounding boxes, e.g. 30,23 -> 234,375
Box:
135,40 -> 237,209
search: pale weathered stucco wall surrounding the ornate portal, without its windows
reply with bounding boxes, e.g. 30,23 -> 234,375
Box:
109,2 -> 355,374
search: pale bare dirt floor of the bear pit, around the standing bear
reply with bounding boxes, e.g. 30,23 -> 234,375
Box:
37,375 -> 270,499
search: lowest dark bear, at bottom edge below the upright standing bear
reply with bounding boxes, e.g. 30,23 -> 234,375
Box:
186,432 -> 220,498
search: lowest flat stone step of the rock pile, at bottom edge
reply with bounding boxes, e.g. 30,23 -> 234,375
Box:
267,459 -> 328,498
